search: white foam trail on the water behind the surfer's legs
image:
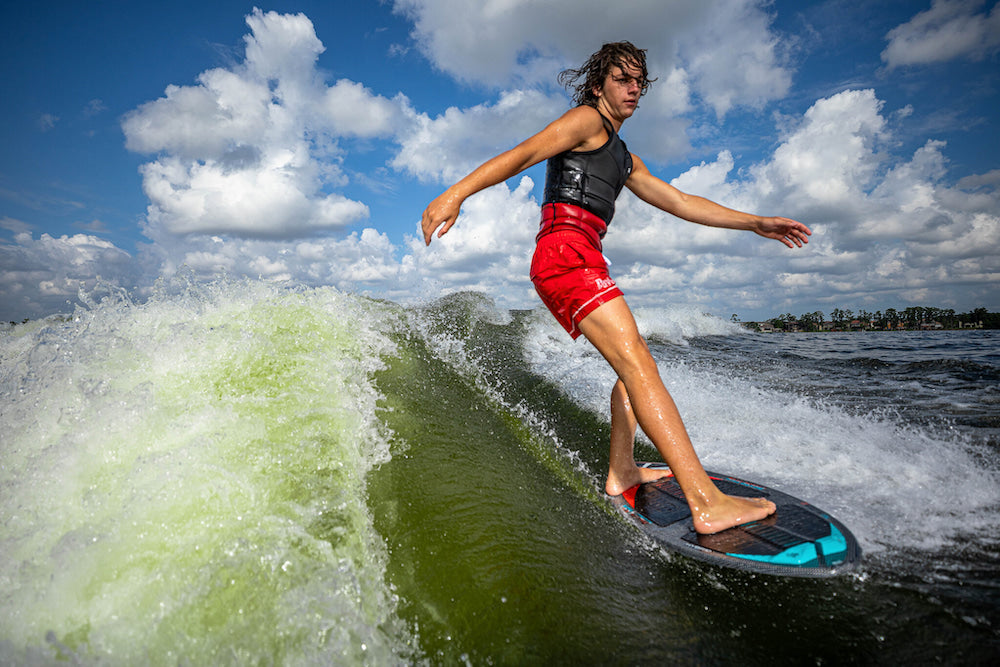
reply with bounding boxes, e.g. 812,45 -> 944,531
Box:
525,311 -> 1000,553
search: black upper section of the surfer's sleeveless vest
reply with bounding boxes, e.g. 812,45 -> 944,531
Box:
544,110 -> 632,223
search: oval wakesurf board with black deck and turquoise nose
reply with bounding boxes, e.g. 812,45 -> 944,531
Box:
611,463 -> 861,577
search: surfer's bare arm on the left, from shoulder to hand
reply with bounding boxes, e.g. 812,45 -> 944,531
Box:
420,107 -> 604,245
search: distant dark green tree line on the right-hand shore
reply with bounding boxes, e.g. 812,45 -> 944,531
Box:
732,306 -> 1000,331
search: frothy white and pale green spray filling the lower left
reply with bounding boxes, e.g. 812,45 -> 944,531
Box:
0,281 -> 411,664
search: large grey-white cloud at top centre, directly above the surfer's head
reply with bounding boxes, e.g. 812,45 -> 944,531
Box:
394,0 -> 792,160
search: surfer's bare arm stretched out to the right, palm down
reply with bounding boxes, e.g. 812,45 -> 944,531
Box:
625,153 -> 812,248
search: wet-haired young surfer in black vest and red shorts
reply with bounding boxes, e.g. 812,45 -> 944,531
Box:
421,42 -> 812,533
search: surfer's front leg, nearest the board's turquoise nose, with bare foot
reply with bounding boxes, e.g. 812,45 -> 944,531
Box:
579,297 -> 775,533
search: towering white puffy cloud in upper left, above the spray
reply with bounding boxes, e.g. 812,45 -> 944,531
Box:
122,10 -> 407,239
